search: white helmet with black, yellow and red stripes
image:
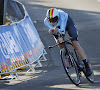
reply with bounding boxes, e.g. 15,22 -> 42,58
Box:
46,8 -> 59,19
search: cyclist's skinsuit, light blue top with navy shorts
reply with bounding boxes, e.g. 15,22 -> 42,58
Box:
44,10 -> 78,41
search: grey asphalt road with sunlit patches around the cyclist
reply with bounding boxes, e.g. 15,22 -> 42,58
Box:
0,0 -> 100,90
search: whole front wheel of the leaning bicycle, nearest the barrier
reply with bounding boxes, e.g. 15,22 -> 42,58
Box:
60,50 -> 80,85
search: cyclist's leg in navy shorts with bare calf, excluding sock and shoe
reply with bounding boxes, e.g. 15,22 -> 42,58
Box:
66,16 -> 86,60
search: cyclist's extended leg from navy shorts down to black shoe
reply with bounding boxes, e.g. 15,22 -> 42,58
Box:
68,20 -> 92,76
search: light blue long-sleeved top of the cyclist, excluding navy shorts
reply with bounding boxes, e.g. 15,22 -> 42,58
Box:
44,10 -> 68,33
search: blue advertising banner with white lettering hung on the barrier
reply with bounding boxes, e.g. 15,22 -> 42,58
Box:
0,13 -> 43,70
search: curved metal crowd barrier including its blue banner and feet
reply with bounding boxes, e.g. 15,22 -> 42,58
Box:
0,0 -> 47,79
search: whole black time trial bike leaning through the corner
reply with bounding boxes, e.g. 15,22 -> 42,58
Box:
48,34 -> 94,85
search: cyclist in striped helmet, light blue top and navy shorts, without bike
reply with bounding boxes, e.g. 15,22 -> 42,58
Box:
44,8 -> 92,76
